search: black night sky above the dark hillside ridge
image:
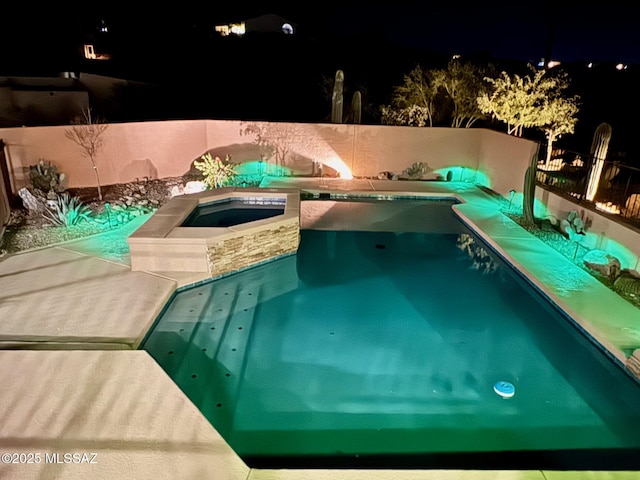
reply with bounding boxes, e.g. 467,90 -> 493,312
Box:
5,0 -> 640,68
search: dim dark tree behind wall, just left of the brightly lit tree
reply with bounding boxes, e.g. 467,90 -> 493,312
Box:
430,59 -> 491,128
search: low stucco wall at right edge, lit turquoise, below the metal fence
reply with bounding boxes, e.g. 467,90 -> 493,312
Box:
535,187 -> 640,270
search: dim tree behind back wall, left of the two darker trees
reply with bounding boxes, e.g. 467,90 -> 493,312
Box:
382,65 -> 438,127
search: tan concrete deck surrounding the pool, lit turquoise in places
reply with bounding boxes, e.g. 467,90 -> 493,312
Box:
0,179 -> 640,480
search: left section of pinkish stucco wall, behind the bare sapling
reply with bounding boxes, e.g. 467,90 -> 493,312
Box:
0,121 -> 207,193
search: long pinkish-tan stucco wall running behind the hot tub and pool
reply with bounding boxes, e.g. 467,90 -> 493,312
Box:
0,120 -> 535,194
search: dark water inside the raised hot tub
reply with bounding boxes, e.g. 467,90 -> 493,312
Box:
181,199 -> 284,227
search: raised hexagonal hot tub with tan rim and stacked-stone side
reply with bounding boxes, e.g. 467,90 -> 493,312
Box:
127,187 -> 300,280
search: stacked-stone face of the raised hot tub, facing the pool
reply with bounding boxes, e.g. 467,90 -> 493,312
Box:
207,221 -> 300,277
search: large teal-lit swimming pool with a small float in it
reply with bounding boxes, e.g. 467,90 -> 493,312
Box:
143,198 -> 640,470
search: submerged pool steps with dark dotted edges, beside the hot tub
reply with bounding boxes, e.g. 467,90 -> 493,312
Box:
144,282 -> 262,430
